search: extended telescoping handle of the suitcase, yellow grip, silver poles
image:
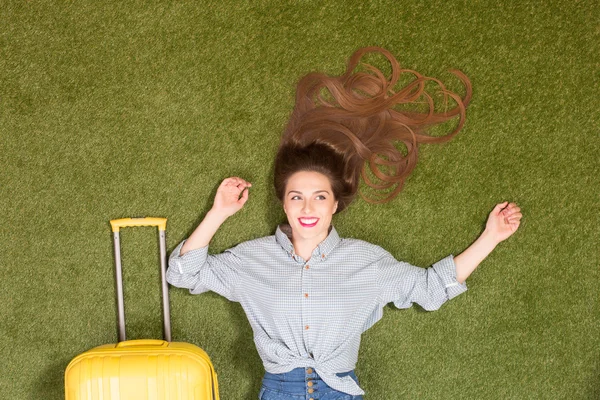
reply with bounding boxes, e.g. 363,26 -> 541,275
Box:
110,217 -> 171,342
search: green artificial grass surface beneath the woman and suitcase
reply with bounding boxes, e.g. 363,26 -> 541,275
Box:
0,0 -> 600,400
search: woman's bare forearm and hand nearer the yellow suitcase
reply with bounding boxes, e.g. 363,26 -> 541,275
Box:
180,177 -> 252,255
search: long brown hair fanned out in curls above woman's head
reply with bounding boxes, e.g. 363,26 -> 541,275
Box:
275,47 -> 472,212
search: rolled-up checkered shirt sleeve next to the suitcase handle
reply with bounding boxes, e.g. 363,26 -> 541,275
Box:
167,240 -> 241,301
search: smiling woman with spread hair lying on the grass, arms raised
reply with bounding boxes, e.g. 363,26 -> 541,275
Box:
167,47 -> 522,400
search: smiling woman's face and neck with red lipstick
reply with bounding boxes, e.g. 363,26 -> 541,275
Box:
283,171 -> 337,244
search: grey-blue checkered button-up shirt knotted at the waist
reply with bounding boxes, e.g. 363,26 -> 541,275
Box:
167,224 -> 467,395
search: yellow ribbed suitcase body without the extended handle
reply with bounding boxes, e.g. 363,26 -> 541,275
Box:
65,341 -> 219,400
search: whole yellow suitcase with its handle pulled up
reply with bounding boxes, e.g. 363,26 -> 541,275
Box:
65,218 -> 219,400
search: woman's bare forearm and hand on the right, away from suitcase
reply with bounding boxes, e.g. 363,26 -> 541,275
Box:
454,201 -> 523,284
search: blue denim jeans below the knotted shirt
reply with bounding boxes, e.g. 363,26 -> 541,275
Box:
258,368 -> 363,400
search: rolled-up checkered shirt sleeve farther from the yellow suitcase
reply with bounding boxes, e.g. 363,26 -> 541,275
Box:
378,249 -> 467,311
